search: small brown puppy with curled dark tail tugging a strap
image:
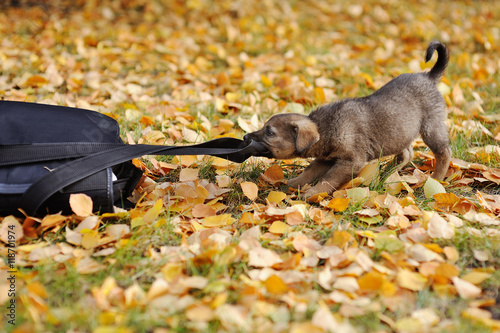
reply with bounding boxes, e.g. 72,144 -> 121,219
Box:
244,41 -> 451,197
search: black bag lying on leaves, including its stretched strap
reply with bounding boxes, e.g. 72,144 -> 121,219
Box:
0,101 -> 265,216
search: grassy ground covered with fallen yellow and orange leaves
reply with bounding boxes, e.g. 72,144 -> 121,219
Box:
0,0 -> 500,333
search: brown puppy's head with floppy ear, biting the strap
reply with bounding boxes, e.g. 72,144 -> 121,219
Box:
244,113 -> 320,159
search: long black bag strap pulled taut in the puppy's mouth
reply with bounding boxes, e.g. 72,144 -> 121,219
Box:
19,138 -> 266,216
